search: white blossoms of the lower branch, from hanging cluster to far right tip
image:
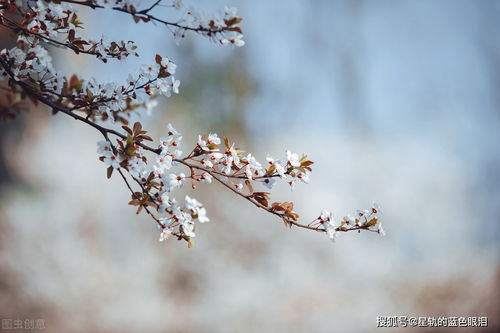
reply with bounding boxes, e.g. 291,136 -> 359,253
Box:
94,119 -> 385,241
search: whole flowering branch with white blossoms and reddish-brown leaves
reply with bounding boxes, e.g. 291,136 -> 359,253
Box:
0,0 -> 384,246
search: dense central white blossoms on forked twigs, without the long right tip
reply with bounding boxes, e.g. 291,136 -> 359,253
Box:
97,123 -> 312,240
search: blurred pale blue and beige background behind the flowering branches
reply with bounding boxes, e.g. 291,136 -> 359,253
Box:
0,0 -> 500,332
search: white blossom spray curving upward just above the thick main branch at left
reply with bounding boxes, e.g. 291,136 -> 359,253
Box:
0,36 -> 180,121
